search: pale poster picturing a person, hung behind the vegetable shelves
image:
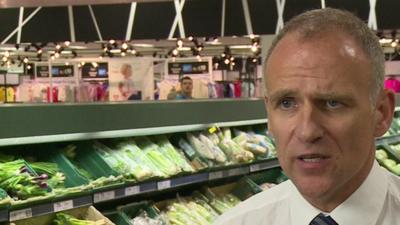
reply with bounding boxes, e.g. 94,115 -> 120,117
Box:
108,57 -> 154,101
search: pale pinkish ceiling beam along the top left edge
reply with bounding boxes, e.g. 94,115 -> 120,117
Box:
0,0 -> 173,8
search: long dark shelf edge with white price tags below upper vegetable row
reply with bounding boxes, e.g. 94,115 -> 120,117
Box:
6,159 -> 279,222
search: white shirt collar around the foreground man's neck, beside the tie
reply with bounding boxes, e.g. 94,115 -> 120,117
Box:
290,161 -> 388,225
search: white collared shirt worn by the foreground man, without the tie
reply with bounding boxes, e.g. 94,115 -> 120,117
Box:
214,161 -> 400,225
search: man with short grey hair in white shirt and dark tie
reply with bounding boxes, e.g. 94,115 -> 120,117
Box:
215,9 -> 400,225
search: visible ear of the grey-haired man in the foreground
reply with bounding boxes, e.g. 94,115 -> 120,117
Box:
374,89 -> 395,137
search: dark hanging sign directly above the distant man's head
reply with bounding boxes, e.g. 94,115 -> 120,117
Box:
168,62 -> 209,75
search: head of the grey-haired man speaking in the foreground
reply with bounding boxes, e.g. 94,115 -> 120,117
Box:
265,9 -> 394,211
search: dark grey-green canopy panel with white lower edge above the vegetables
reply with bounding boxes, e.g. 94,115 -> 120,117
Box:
0,98 -> 267,146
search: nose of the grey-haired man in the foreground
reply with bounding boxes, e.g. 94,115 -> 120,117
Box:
296,104 -> 324,143
